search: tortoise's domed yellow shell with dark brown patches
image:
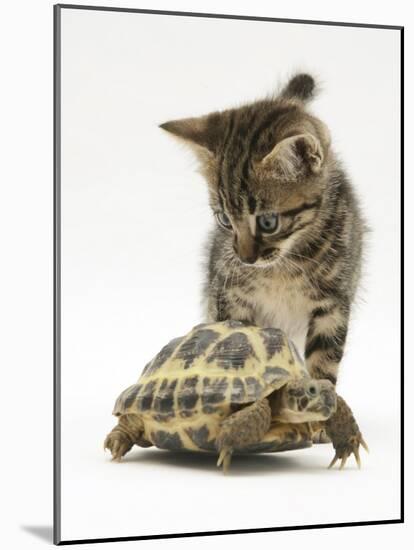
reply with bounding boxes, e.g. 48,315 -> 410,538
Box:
113,321 -> 310,452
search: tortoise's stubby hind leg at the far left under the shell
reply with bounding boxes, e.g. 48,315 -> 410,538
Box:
104,414 -> 152,462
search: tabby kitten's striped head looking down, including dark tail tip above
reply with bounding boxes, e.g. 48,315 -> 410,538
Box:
161,74 -> 330,266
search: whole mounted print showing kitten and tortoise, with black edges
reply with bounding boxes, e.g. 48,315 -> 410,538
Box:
55,5 -> 403,544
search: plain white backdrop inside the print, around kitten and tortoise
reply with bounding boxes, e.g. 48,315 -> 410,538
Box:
62,6 -> 400,540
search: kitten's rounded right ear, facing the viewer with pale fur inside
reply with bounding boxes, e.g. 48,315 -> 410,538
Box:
260,133 -> 324,181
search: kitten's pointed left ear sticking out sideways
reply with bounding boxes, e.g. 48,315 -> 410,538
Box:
160,113 -> 221,153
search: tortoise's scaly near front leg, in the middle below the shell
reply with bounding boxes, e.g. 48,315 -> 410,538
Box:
216,399 -> 272,473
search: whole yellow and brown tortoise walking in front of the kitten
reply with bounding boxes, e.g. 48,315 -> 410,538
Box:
104,320 -> 368,472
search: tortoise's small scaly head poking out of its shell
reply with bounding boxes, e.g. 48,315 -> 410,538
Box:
273,377 -> 336,423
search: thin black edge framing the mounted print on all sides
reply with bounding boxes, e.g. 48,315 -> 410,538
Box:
53,4 -> 404,545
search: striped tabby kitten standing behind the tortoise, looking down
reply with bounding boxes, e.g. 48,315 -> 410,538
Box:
161,74 -> 364,384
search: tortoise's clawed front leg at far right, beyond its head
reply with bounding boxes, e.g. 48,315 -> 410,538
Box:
325,395 -> 368,470
